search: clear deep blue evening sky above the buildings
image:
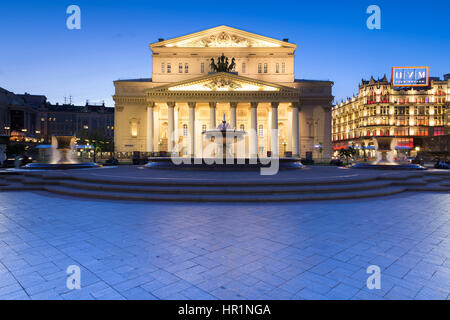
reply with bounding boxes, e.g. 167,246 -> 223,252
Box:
0,0 -> 450,106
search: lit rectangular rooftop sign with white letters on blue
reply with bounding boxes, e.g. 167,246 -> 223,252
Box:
392,67 -> 429,87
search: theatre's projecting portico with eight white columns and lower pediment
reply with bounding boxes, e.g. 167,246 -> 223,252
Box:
141,73 -> 299,157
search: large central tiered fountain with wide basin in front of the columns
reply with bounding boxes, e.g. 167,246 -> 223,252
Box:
145,114 -> 303,170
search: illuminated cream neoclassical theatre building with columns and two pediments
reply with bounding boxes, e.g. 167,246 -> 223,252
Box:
113,26 -> 333,158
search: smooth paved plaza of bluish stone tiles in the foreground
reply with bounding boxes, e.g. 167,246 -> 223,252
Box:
0,192 -> 450,299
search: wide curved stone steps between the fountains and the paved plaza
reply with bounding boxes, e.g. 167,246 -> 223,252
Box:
0,171 -> 450,202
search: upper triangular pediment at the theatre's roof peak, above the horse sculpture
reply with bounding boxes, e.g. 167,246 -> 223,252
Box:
150,26 -> 297,49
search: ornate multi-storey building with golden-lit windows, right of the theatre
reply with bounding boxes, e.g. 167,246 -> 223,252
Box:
332,75 -> 450,154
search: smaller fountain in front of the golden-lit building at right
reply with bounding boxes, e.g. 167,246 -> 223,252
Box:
351,137 -> 426,170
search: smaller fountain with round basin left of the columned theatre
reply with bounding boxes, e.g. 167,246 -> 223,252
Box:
23,136 -> 100,170
